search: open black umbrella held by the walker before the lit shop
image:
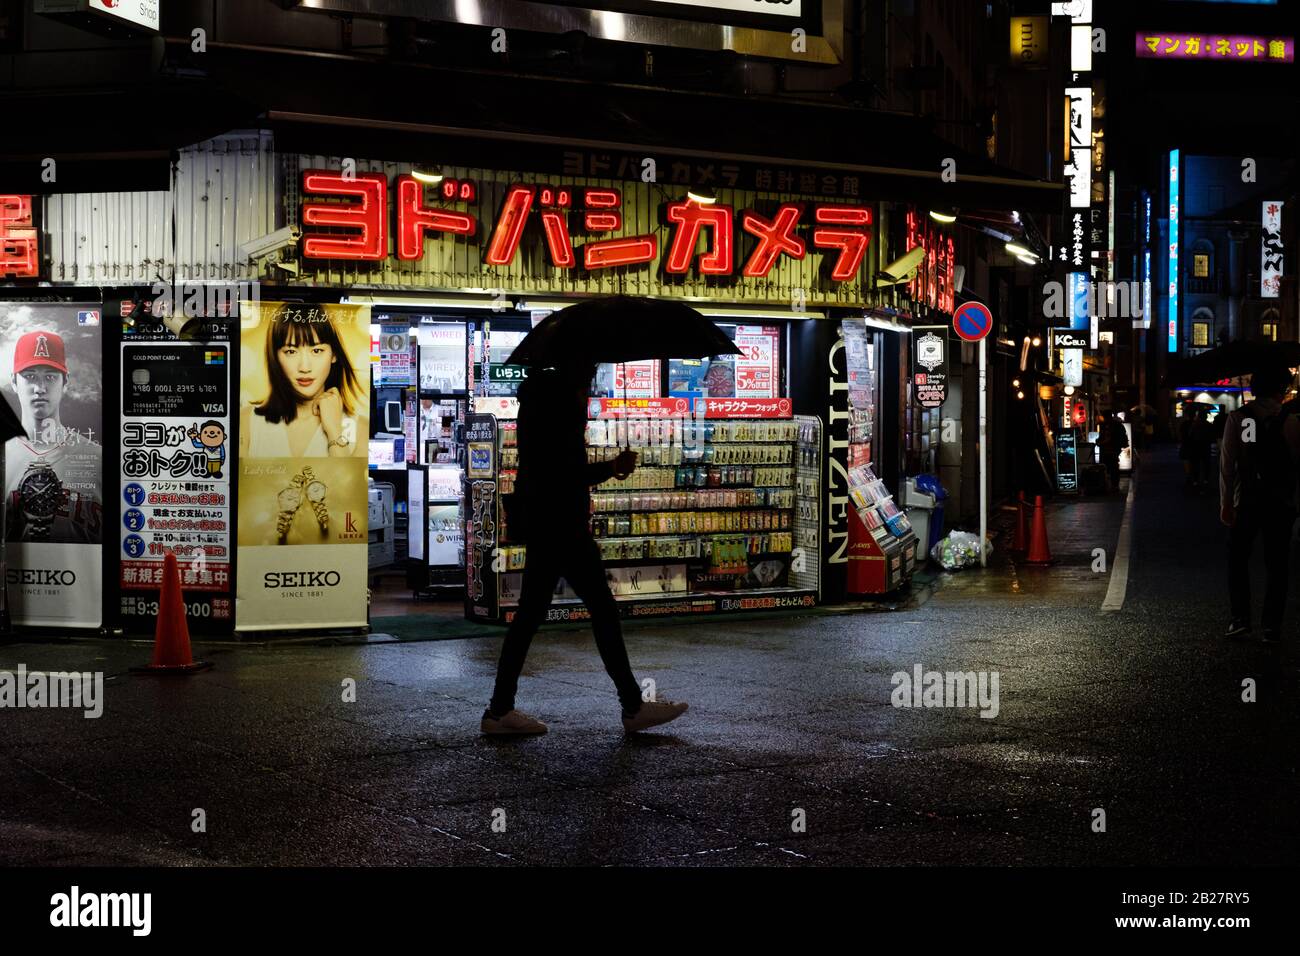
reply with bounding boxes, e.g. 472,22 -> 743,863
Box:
506,295 -> 740,368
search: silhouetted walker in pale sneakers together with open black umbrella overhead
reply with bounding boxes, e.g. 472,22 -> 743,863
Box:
480,297 -> 736,735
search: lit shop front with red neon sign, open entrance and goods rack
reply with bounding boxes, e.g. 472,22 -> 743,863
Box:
276,149 -> 901,622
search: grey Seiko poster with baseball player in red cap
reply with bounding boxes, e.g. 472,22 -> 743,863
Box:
0,303 -> 104,627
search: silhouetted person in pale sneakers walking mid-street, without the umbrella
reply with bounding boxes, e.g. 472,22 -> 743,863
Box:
481,367 -> 686,734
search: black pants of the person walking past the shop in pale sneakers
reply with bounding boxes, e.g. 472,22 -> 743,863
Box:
491,529 -> 641,714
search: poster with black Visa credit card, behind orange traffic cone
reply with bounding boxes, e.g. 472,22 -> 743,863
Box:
120,333 -> 234,632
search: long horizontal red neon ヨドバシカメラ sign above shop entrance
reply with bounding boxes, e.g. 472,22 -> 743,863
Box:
302,170 -> 872,282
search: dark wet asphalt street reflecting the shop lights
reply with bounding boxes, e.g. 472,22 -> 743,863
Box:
0,450 -> 1300,866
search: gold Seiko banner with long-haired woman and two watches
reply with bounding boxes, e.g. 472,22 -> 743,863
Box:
235,302 -> 371,631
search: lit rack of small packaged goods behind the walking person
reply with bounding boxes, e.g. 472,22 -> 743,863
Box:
465,415 -> 820,623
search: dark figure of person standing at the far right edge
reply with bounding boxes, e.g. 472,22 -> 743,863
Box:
1219,365 -> 1300,644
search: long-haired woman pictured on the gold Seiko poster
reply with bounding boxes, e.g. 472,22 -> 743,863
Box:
239,306 -> 369,458
